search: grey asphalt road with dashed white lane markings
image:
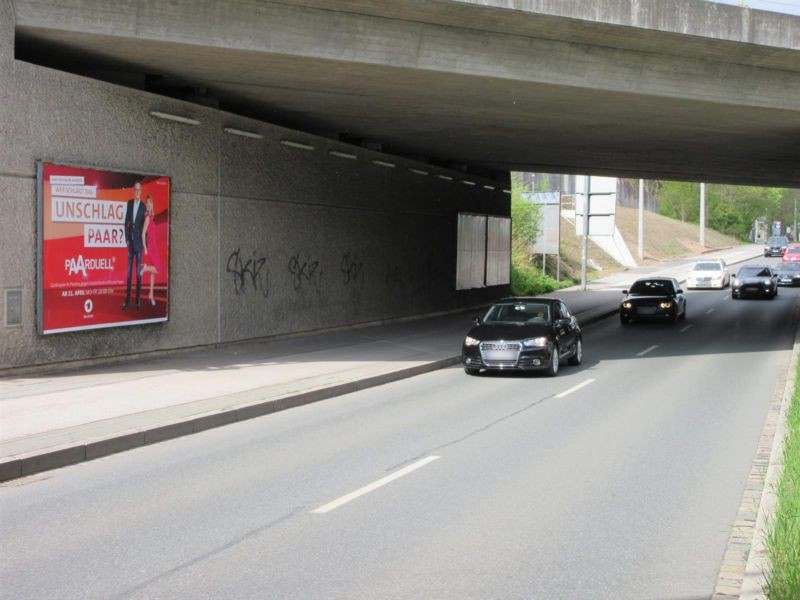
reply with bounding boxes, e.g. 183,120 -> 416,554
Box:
0,259 -> 800,600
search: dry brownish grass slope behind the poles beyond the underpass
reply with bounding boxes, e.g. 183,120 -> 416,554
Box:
547,206 -> 741,279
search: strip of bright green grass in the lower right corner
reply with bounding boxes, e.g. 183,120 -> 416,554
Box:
766,365 -> 800,600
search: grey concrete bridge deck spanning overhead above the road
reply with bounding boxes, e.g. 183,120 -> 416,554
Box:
13,0 -> 800,187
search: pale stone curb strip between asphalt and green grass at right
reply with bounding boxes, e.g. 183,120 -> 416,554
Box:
712,296 -> 800,600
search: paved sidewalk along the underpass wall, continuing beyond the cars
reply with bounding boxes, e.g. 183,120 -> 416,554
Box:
0,245 -> 762,481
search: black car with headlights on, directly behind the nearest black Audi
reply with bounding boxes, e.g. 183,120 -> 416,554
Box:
619,277 -> 686,325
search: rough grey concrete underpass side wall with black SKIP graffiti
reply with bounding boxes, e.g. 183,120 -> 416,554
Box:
0,5 -> 510,369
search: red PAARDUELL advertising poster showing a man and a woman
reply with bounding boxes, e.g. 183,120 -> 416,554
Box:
38,163 -> 170,334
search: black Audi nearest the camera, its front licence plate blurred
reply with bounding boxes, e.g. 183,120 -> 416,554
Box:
461,297 -> 583,376
